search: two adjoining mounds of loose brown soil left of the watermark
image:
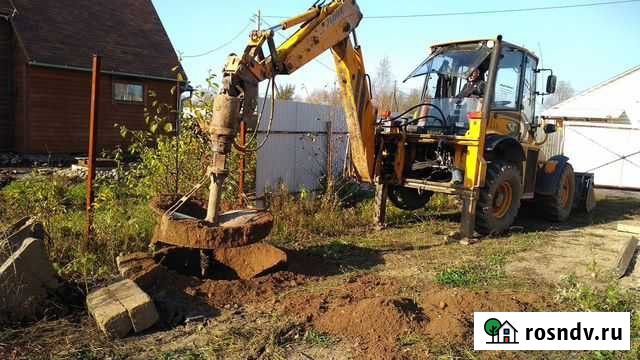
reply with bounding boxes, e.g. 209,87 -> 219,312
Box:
282,275 -> 541,359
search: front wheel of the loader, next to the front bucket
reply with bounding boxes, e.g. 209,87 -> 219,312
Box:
536,164 -> 576,222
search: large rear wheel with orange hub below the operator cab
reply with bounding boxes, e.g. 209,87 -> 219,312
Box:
476,161 -> 522,235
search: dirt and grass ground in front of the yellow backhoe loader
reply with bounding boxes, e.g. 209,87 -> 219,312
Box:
0,191 -> 640,360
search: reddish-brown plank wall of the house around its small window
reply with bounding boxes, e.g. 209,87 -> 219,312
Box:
22,66 -> 176,153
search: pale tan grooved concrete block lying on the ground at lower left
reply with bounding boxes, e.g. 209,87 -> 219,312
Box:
87,279 -> 159,338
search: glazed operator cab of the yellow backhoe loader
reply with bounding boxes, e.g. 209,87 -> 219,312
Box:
405,40 -> 538,138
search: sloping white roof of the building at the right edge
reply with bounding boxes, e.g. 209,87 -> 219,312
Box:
542,66 -> 640,125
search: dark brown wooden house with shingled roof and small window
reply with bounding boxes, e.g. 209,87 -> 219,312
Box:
0,0 -> 182,154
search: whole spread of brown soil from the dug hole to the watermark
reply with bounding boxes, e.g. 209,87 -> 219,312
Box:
121,249 -> 542,360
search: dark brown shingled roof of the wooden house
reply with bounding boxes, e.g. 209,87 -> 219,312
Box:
0,0 -> 185,79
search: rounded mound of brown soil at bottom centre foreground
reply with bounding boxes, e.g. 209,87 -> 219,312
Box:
314,297 -> 427,359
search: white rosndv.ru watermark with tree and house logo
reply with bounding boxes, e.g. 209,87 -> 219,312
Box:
473,312 -> 631,350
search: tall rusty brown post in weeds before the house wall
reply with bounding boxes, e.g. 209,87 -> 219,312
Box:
83,55 -> 101,250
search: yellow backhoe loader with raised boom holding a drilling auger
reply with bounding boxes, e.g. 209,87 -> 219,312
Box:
191,0 -> 593,256
